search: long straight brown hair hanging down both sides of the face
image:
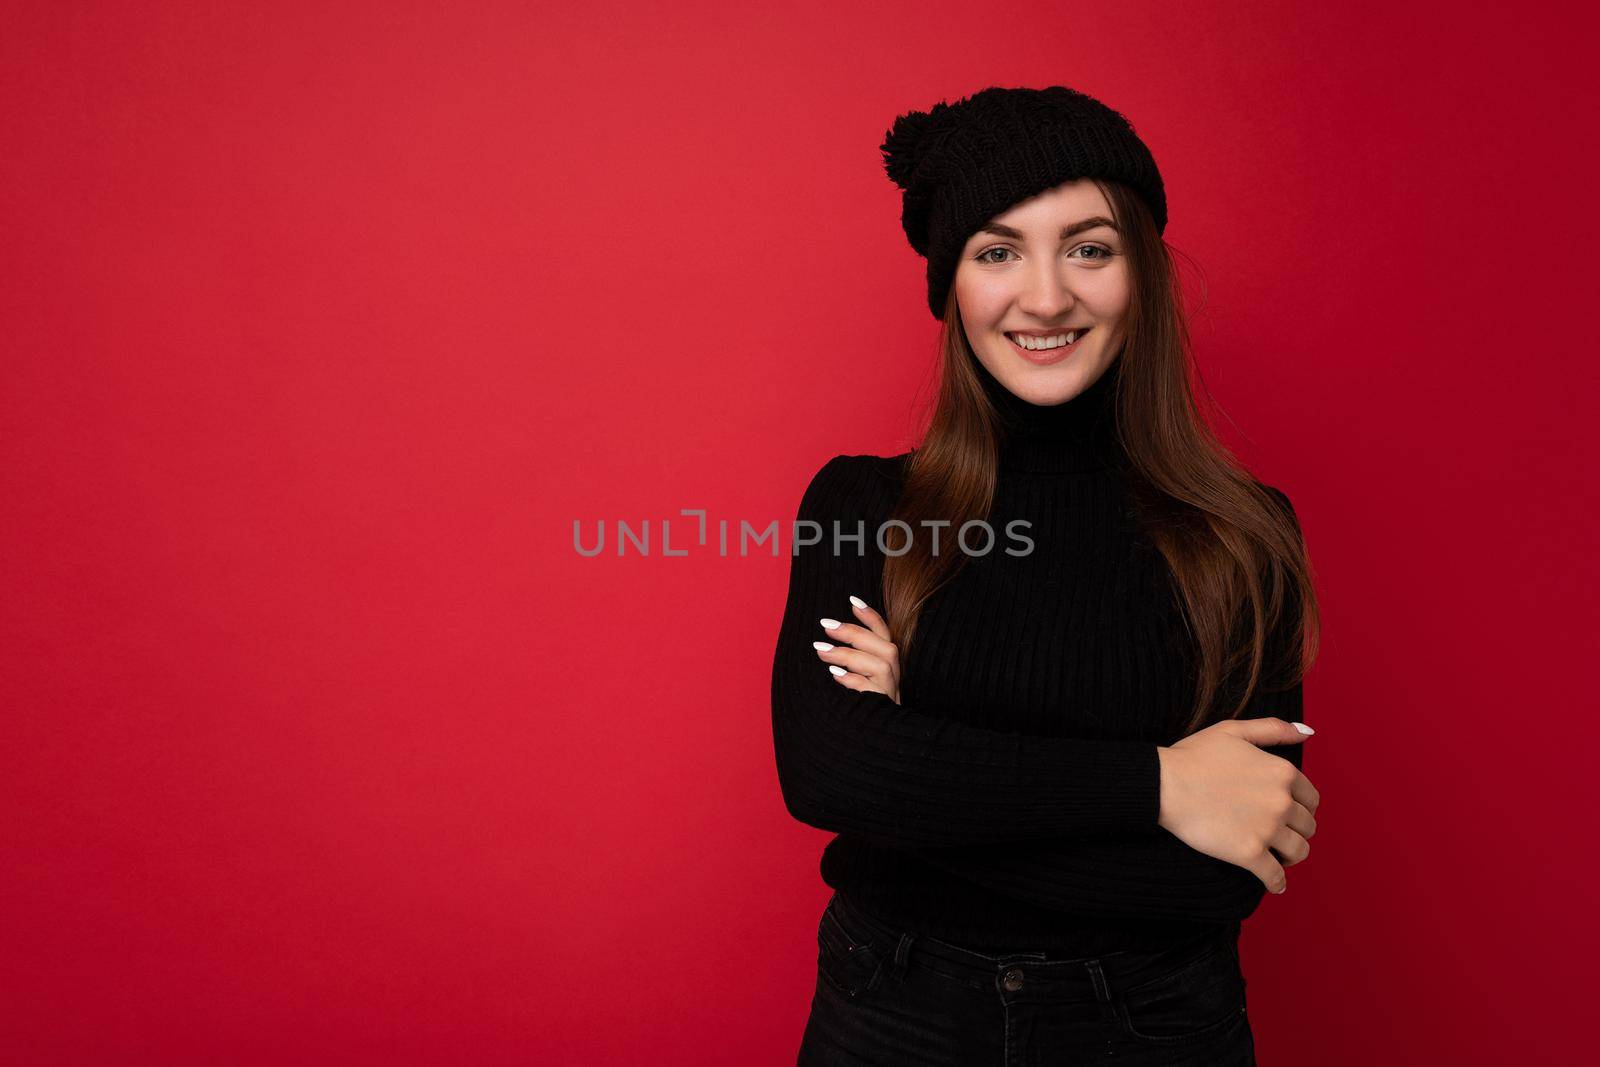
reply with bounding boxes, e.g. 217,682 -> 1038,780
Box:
883,181 -> 1320,734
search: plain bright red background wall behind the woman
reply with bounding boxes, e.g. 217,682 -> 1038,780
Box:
0,0 -> 1600,1065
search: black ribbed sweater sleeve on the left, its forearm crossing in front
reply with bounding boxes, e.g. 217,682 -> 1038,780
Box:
771,456 -> 1160,848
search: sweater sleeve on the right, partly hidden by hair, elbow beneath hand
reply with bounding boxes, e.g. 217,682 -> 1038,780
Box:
918,486 -> 1307,921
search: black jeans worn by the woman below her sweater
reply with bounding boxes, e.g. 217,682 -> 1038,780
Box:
798,893 -> 1256,1067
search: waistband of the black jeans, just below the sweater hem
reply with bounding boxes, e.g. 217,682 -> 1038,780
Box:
827,893 -> 1240,1001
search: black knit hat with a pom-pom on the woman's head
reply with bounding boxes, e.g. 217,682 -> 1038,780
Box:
880,85 -> 1166,320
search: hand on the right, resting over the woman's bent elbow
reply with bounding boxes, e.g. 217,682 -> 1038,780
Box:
1157,718 -> 1320,893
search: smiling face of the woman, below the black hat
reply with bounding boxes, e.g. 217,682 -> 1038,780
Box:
952,179 -> 1131,405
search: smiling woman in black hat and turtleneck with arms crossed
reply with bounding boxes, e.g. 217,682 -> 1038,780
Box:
773,86 -> 1318,1067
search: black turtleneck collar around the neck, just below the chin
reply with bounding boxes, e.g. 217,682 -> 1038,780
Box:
973,360 -> 1125,474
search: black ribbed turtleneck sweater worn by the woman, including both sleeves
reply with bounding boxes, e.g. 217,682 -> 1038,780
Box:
771,365 -> 1302,953
